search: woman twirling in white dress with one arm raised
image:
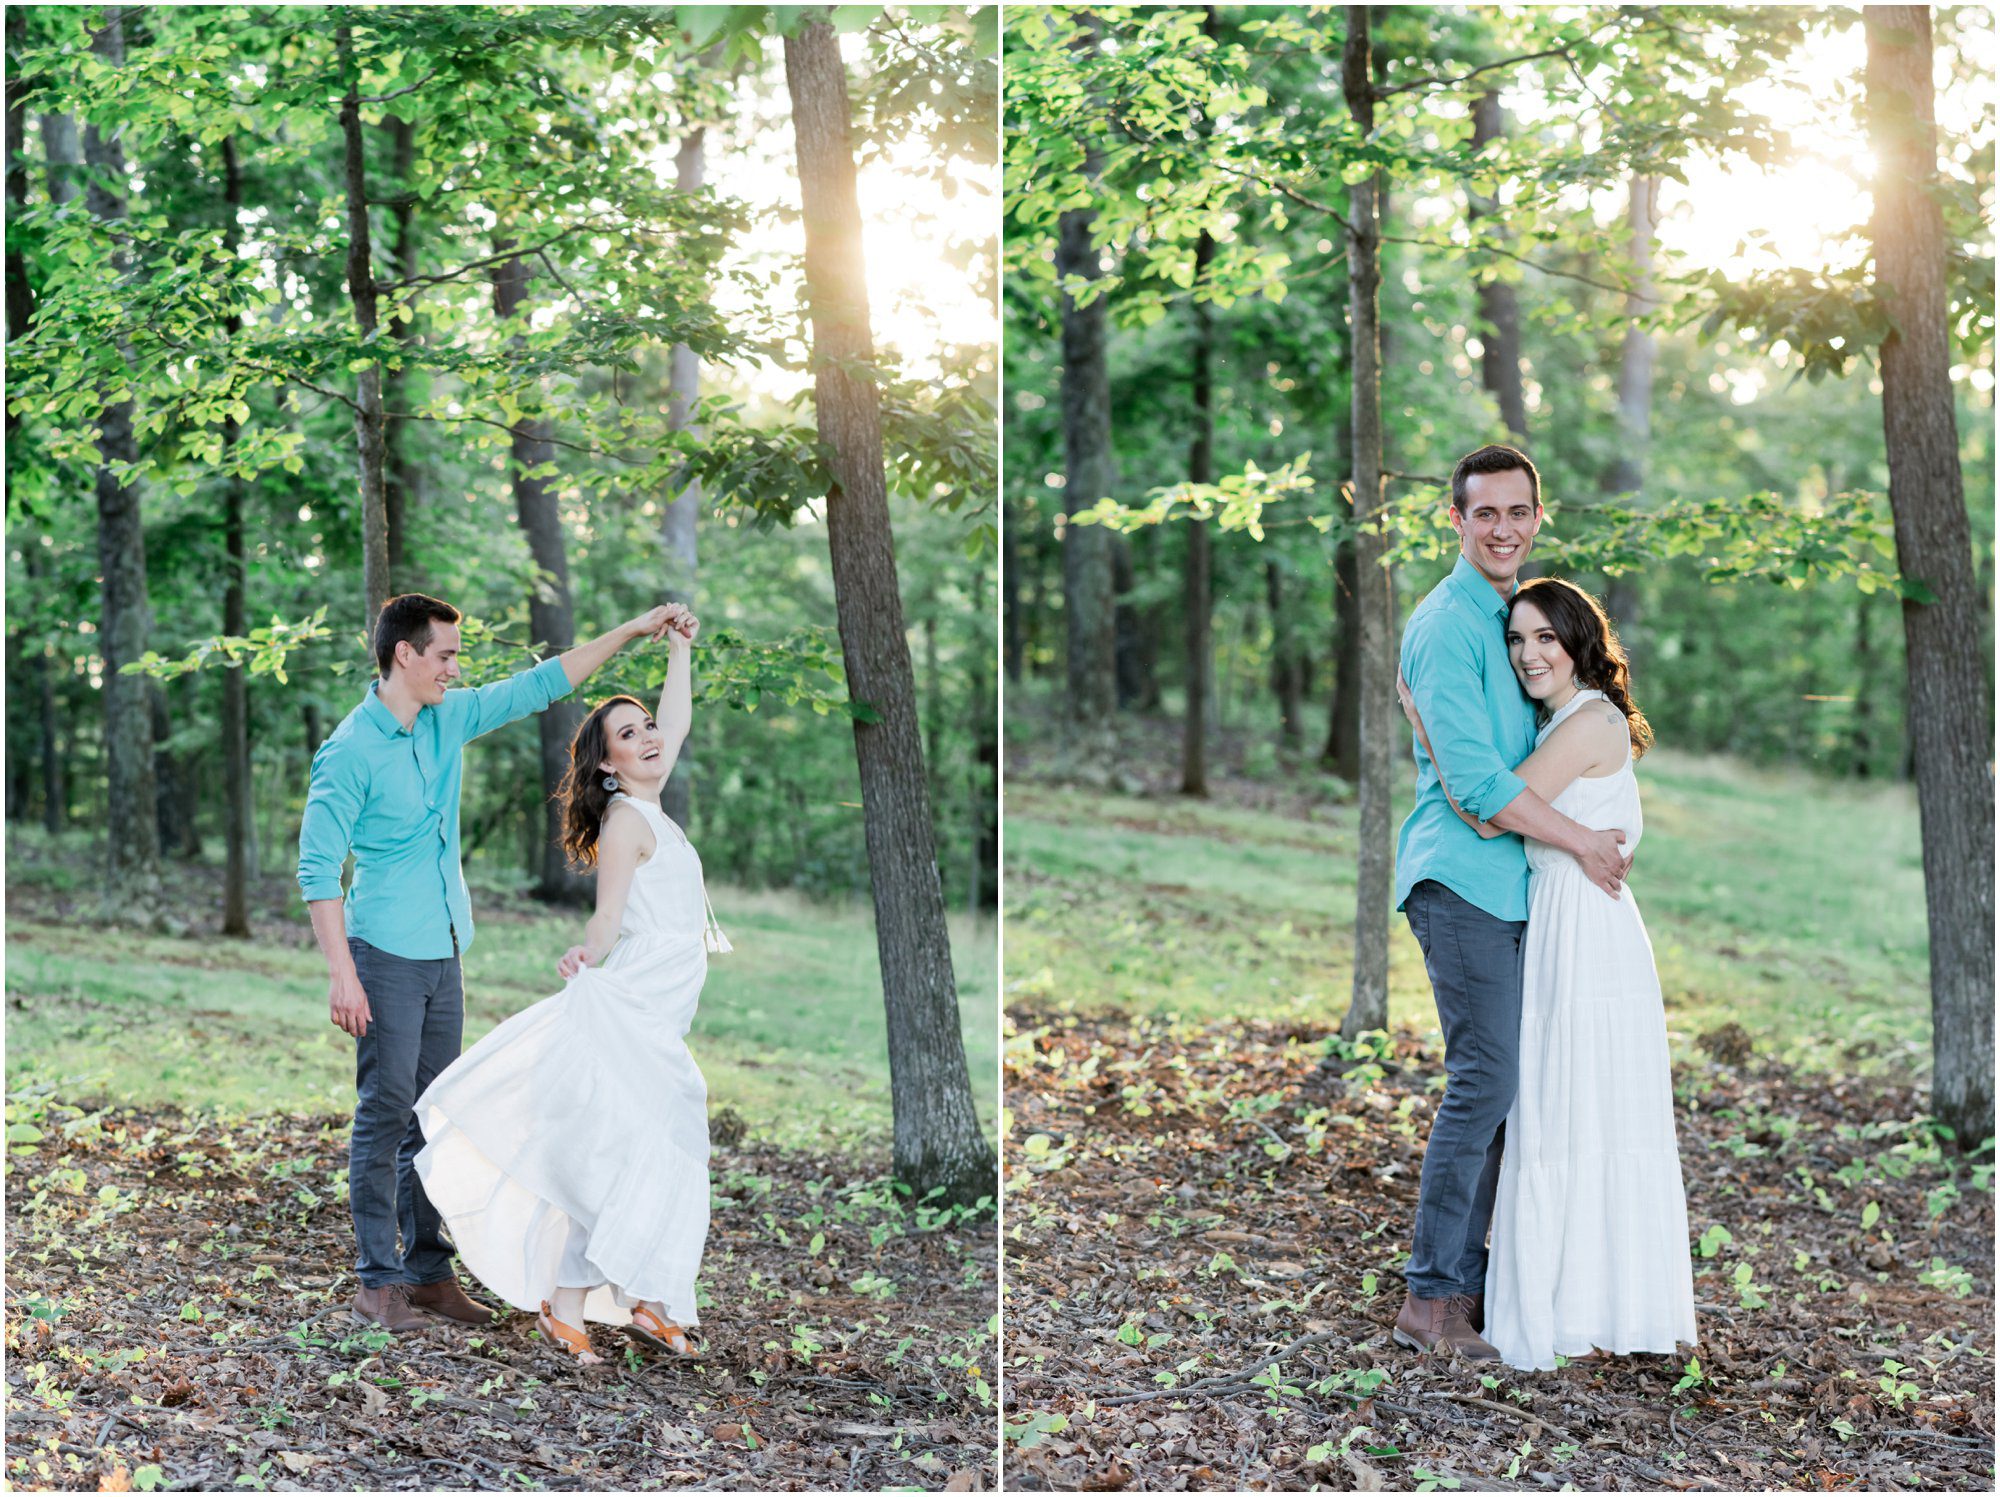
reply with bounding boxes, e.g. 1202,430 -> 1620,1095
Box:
416,604 -> 730,1363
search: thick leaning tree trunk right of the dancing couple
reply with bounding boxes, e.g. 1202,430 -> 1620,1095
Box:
784,10 -> 998,1205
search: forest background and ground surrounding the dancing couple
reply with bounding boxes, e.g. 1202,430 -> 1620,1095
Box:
6,6 -> 998,1489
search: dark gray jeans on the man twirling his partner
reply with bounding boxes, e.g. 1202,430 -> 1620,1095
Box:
348,937 -> 466,1289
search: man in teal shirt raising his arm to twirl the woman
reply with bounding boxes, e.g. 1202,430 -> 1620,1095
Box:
298,592 -> 670,1335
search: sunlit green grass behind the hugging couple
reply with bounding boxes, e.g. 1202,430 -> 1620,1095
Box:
1004,749 -> 1930,1071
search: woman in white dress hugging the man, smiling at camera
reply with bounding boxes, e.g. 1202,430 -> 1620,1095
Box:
1404,576 -> 1696,1369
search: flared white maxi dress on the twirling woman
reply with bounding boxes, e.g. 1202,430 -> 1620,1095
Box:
416,795 -> 730,1325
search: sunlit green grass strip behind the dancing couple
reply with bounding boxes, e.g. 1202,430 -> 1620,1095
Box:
6,865 -> 998,1153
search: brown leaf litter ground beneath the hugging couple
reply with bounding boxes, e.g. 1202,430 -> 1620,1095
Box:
1004,1005 -> 1994,1491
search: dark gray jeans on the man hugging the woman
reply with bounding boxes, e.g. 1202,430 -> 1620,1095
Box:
1402,879 -> 1528,1299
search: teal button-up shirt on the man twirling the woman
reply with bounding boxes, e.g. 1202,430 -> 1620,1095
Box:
298,658 -> 570,961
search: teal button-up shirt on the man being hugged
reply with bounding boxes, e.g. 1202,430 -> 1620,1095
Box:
1396,556 -> 1534,921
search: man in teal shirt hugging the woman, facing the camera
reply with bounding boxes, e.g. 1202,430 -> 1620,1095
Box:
1394,446 -> 1630,1359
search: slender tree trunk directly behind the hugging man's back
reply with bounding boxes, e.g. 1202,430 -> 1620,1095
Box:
1340,6 -> 1396,1039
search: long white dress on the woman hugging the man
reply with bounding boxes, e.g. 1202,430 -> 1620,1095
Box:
1484,688 -> 1694,1369
